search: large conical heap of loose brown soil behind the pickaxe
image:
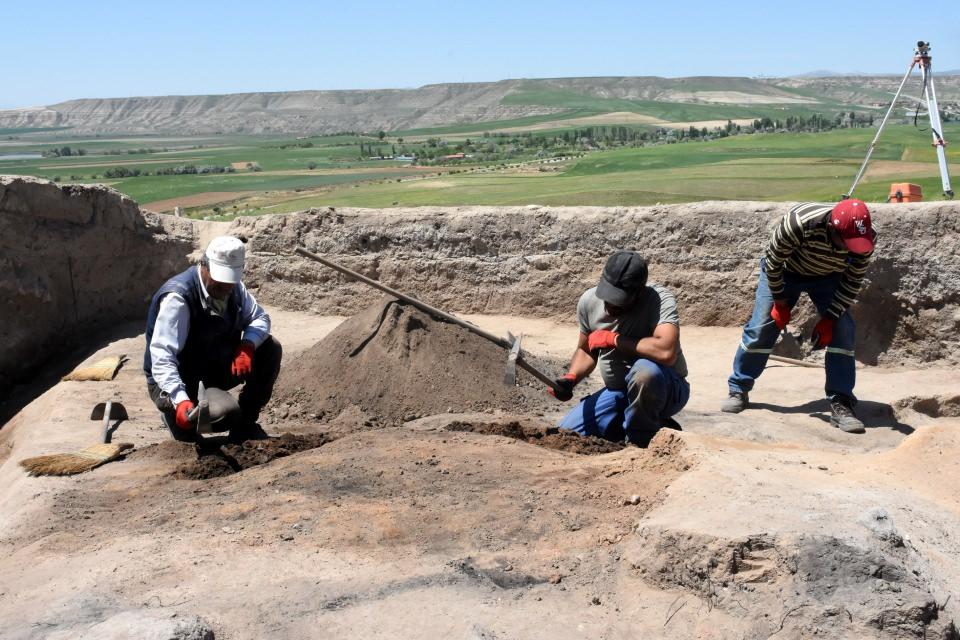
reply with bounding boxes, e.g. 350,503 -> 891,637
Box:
274,299 -> 559,425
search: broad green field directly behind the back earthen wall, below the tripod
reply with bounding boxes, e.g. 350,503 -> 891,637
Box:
276,125 -> 960,211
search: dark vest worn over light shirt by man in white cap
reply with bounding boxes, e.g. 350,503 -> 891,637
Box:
143,267 -> 243,378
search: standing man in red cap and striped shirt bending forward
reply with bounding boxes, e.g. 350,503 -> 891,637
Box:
720,199 -> 876,433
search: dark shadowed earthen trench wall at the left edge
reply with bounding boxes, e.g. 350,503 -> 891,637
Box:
0,177 -> 194,398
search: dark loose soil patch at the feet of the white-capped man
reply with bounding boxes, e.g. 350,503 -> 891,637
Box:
173,433 -> 331,480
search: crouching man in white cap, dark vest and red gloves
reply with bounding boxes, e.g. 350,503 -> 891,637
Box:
143,236 -> 282,441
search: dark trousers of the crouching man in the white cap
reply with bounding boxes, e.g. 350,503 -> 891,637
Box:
147,336 -> 283,442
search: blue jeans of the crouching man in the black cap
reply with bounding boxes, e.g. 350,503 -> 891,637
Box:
560,358 -> 690,442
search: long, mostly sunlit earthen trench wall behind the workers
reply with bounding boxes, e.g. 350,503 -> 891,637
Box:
232,202 -> 960,363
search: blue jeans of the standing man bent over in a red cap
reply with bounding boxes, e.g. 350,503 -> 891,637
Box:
727,258 -> 857,402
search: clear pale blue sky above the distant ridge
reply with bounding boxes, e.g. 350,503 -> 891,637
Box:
0,0 -> 960,108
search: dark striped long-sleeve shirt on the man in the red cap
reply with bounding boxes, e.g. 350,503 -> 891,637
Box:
766,202 -> 873,319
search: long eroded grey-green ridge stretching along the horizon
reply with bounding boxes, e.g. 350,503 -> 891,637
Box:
0,73 -> 960,134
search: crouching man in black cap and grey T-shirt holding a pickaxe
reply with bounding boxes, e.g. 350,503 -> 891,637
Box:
550,251 -> 690,446
